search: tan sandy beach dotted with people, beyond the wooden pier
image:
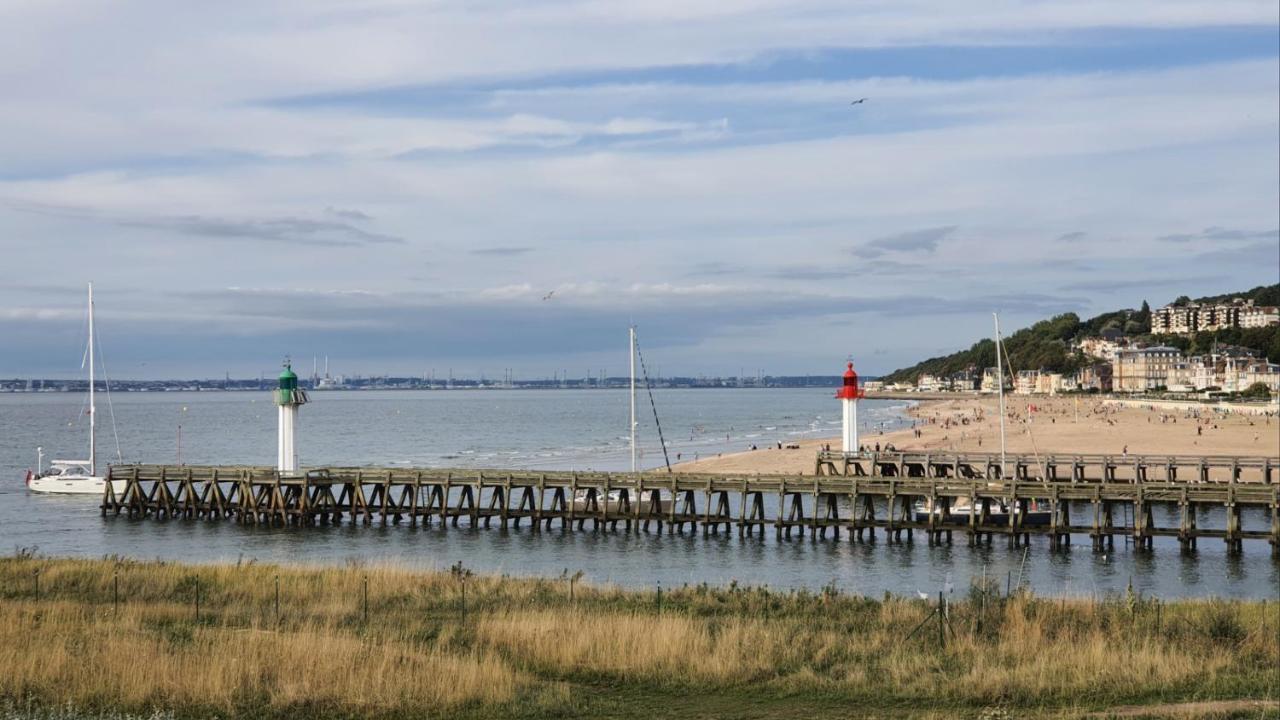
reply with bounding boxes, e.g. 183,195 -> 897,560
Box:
676,396 -> 1280,474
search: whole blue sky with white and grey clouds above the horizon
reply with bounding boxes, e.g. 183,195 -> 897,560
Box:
0,0 -> 1280,379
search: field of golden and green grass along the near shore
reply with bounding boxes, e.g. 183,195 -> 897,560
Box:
0,555 -> 1280,719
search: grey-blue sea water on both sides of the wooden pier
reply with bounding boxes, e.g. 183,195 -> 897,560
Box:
0,389 -> 1280,598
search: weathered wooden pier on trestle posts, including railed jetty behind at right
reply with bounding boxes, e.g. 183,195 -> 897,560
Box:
101,452 -> 1280,557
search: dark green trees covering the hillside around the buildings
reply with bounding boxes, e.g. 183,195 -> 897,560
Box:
883,283 -> 1280,383
